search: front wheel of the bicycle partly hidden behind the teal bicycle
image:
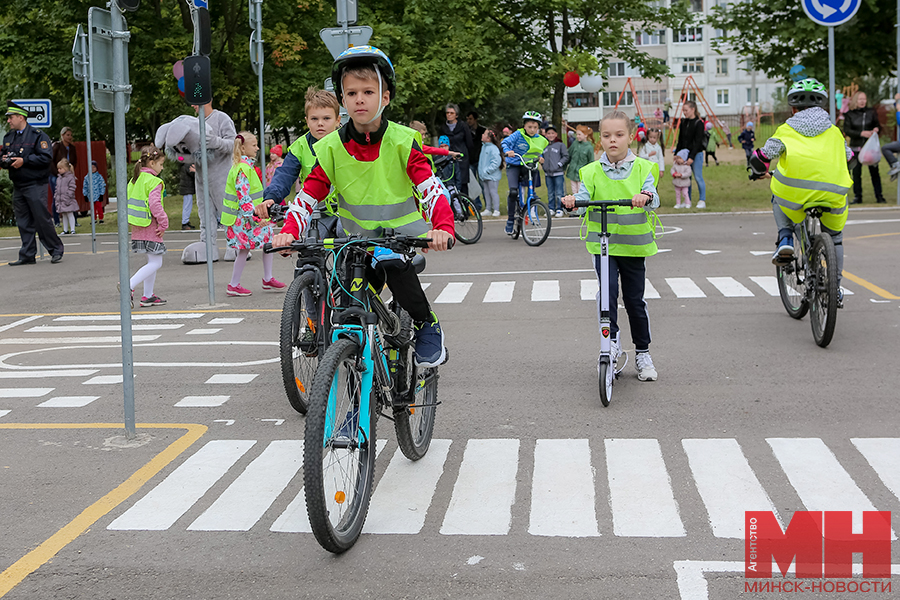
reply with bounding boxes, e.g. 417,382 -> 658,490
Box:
279,273 -> 330,415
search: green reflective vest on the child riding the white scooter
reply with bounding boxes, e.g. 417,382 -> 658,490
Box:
579,158 -> 658,256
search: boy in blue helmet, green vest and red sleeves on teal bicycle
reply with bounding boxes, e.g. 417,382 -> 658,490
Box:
273,46 -> 454,367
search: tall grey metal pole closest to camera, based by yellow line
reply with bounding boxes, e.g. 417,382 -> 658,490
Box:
110,0 -> 135,439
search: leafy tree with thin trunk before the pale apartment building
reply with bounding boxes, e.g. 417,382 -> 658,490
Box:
477,0 -> 690,127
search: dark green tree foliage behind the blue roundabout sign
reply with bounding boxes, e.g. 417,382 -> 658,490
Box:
708,0 -> 897,84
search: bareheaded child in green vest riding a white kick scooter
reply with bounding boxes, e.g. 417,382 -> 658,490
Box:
562,111 -> 659,381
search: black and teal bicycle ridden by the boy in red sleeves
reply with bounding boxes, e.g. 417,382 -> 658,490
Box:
292,234 -> 452,553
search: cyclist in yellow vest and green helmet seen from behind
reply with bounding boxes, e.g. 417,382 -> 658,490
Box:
750,78 -> 853,307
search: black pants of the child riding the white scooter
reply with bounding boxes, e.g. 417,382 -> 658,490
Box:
594,254 -> 650,352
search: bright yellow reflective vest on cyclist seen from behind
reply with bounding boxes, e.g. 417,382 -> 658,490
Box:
771,123 -> 853,231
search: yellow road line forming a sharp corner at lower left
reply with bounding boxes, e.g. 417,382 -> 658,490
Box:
0,423 -> 207,598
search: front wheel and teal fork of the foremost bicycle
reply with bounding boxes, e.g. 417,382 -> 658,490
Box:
303,339 -> 377,554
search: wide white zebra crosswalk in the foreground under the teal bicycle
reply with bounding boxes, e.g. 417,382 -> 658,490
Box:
109,436 -> 900,539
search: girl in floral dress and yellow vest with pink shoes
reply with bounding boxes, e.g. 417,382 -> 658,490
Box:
222,131 -> 285,296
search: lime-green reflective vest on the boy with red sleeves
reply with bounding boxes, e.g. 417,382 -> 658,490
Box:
315,122 -> 431,237
